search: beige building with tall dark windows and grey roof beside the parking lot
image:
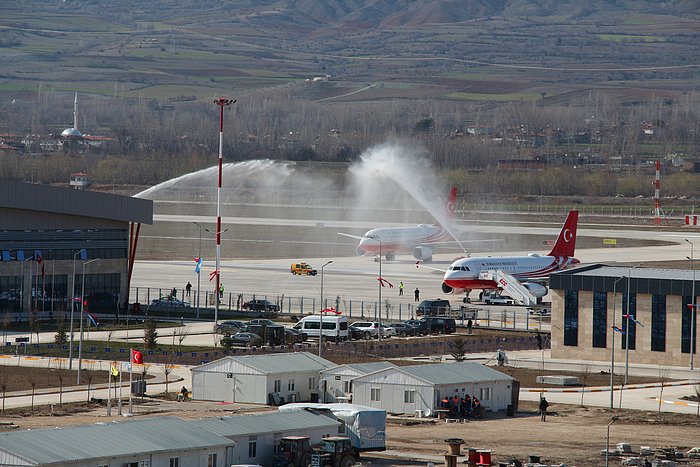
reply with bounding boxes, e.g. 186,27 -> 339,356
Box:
550,265 -> 700,367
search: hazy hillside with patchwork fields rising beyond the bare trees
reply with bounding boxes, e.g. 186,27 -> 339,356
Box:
0,0 -> 700,104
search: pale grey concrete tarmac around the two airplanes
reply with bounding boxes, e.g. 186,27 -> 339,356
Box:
131,216 -> 700,306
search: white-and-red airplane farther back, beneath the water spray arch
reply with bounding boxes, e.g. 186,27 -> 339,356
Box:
338,187 -> 457,261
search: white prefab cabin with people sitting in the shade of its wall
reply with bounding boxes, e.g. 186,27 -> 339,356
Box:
352,362 -> 517,415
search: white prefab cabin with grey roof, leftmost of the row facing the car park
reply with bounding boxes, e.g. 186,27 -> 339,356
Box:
192,352 -> 335,405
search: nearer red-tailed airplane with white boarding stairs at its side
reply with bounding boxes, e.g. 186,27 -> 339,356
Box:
442,211 -> 579,304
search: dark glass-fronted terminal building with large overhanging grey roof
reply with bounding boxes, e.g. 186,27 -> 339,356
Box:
0,181 -> 153,321
